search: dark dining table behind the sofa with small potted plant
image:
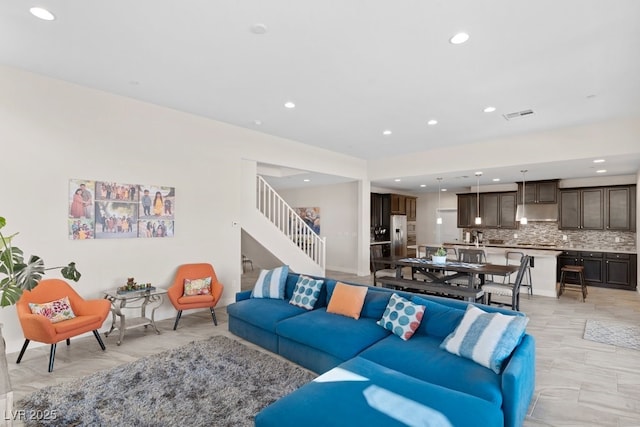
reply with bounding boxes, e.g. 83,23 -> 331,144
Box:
375,256 -> 519,288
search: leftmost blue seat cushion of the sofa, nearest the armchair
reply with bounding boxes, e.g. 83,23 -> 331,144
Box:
227,298 -> 306,333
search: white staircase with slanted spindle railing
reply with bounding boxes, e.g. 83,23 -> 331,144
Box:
243,176 -> 326,276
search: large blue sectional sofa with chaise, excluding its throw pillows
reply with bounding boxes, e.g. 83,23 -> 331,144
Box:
227,273 -> 535,427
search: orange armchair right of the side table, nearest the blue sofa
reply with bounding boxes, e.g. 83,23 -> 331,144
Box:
167,263 -> 224,331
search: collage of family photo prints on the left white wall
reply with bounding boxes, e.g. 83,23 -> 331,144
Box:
67,179 -> 176,240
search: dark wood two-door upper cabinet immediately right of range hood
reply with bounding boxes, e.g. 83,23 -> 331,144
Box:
558,187 -> 604,230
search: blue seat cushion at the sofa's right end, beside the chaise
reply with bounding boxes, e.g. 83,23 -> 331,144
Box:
359,334 -> 502,406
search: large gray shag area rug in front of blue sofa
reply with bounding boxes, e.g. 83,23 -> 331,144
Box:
15,336 -> 316,426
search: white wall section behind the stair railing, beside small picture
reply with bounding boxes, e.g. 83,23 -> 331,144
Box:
279,182 -> 362,274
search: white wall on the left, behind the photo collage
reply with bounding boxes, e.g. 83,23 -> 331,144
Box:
0,66 -> 369,352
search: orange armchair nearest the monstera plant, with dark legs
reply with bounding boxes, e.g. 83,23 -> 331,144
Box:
16,279 -> 111,372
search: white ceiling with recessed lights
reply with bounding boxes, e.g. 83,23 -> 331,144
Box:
0,0 -> 640,189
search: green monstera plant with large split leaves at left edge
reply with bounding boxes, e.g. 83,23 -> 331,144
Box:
0,217 -> 81,307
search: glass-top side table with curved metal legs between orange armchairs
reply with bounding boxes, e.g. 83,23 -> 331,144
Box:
103,287 -> 167,345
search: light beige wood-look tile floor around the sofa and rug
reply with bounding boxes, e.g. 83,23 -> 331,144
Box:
8,268 -> 640,427
